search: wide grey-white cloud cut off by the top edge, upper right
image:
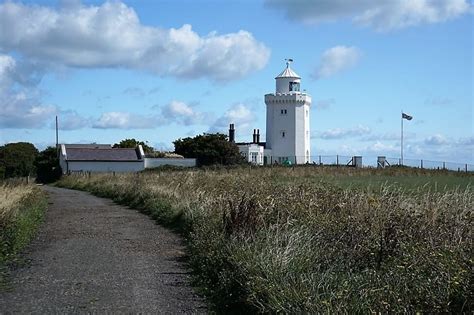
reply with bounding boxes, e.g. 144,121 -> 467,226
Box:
266,0 -> 472,31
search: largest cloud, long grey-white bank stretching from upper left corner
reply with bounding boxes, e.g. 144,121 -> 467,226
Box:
0,1 -> 270,81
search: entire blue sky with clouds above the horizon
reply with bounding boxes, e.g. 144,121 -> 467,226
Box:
0,0 -> 474,163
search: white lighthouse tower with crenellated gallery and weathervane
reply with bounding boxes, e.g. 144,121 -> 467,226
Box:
265,59 -> 311,164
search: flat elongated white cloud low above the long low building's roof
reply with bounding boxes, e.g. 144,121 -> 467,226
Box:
92,112 -> 160,129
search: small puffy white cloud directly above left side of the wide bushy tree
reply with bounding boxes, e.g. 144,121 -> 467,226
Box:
161,101 -> 209,126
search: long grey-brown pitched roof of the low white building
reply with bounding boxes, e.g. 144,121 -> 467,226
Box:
66,148 -> 141,162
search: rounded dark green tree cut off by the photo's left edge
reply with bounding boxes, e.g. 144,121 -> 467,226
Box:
0,142 -> 38,178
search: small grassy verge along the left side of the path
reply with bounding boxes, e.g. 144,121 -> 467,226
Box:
0,184 -> 46,285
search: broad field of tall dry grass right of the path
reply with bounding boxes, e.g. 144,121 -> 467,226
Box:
60,167 -> 474,313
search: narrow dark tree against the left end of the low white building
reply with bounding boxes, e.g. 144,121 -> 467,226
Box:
35,147 -> 62,183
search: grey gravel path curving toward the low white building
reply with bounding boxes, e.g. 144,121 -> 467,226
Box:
0,186 -> 206,314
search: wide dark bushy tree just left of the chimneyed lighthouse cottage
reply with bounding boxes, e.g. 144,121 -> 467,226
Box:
173,133 -> 244,166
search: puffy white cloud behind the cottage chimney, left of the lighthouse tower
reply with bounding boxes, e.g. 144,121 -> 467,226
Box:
210,104 -> 256,132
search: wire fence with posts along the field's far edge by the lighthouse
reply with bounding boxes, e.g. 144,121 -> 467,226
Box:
264,155 -> 474,172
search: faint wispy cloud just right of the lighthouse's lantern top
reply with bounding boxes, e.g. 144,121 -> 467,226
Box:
314,46 -> 362,79
